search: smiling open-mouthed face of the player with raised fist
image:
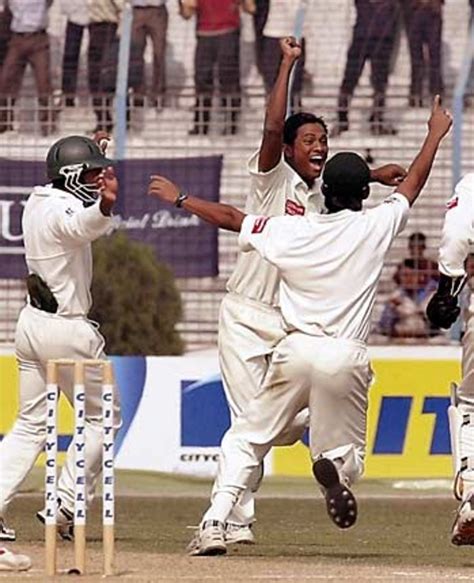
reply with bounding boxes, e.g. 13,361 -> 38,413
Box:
284,123 -> 328,186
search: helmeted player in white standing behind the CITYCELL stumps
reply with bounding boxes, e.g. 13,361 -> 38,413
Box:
0,136 -> 120,540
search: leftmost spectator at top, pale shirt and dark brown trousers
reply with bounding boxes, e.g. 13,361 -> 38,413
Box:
0,0 -> 55,135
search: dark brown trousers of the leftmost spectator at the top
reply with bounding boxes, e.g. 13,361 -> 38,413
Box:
0,31 -> 55,134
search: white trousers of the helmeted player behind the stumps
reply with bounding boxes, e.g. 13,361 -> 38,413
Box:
0,306 -> 121,517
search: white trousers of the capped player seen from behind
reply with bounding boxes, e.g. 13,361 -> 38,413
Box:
204,332 -> 372,520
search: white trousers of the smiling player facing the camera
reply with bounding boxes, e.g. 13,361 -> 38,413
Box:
214,293 -> 309,524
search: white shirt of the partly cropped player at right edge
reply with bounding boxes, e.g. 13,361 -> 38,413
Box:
439,172 -> 474,277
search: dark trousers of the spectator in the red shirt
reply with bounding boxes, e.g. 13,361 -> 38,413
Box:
194,30 -> 240,133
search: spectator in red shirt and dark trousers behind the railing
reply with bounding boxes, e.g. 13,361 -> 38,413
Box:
179,0 -> 253,135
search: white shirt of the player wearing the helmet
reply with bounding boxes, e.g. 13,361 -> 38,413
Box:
22,186 -> 112,317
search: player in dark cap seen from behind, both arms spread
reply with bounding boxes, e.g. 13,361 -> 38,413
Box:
149,96 -> 452,555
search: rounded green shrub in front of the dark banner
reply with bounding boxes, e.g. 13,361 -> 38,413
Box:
90,232 -> 183,355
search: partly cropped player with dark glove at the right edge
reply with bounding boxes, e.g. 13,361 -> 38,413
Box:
427,173 -> 474,545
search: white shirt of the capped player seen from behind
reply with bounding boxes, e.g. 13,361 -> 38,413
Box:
239,193 -> 409,341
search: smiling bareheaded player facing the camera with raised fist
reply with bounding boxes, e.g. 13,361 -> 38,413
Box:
218,37 -> 405,542
